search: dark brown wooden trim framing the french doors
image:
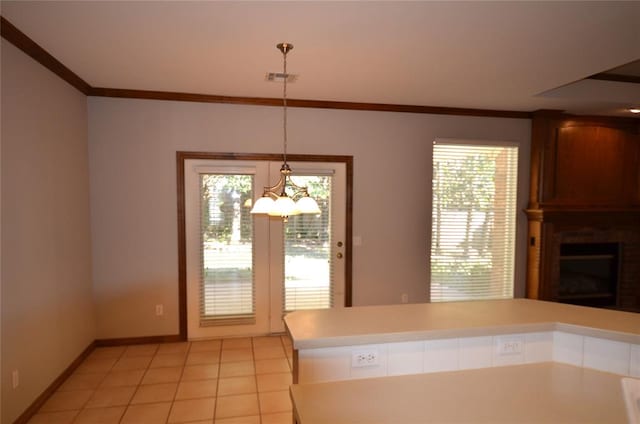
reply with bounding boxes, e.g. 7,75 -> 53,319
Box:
176,151 -> 353,340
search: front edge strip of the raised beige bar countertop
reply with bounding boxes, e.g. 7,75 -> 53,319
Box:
287,322 -> 640,350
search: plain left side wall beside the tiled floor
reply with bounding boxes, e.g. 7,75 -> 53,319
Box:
1,40 -> 95,423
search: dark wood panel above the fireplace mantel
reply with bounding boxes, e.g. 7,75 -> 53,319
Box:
529,112 -> 640,209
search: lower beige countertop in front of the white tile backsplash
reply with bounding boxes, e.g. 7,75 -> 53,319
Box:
291,362 -> 638,424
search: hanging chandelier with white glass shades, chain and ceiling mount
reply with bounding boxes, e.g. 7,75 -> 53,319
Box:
251,43 -> 320,222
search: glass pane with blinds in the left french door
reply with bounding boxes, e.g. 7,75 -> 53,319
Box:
200,174 -> 255,326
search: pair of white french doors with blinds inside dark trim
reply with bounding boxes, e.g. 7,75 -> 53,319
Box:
184,159 -> 346,339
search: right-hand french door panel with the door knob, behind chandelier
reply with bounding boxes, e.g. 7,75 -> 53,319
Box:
261,162 -> 346,333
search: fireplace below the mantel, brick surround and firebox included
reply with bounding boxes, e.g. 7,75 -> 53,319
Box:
527,210 -> 640,312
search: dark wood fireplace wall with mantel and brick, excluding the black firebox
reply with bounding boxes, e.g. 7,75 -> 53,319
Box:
526,111 -> 640,311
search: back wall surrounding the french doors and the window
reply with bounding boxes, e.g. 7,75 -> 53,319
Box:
89,98 -> 530,338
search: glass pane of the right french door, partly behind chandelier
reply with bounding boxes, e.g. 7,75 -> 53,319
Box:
283,175 -> 333,312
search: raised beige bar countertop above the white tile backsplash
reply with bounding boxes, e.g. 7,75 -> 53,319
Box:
284,299 -> 640,349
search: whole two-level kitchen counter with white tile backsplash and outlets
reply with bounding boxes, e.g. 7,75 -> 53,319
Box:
285,299 -> 640,424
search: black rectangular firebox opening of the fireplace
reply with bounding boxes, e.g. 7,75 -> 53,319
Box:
558,243 -> 620,307
